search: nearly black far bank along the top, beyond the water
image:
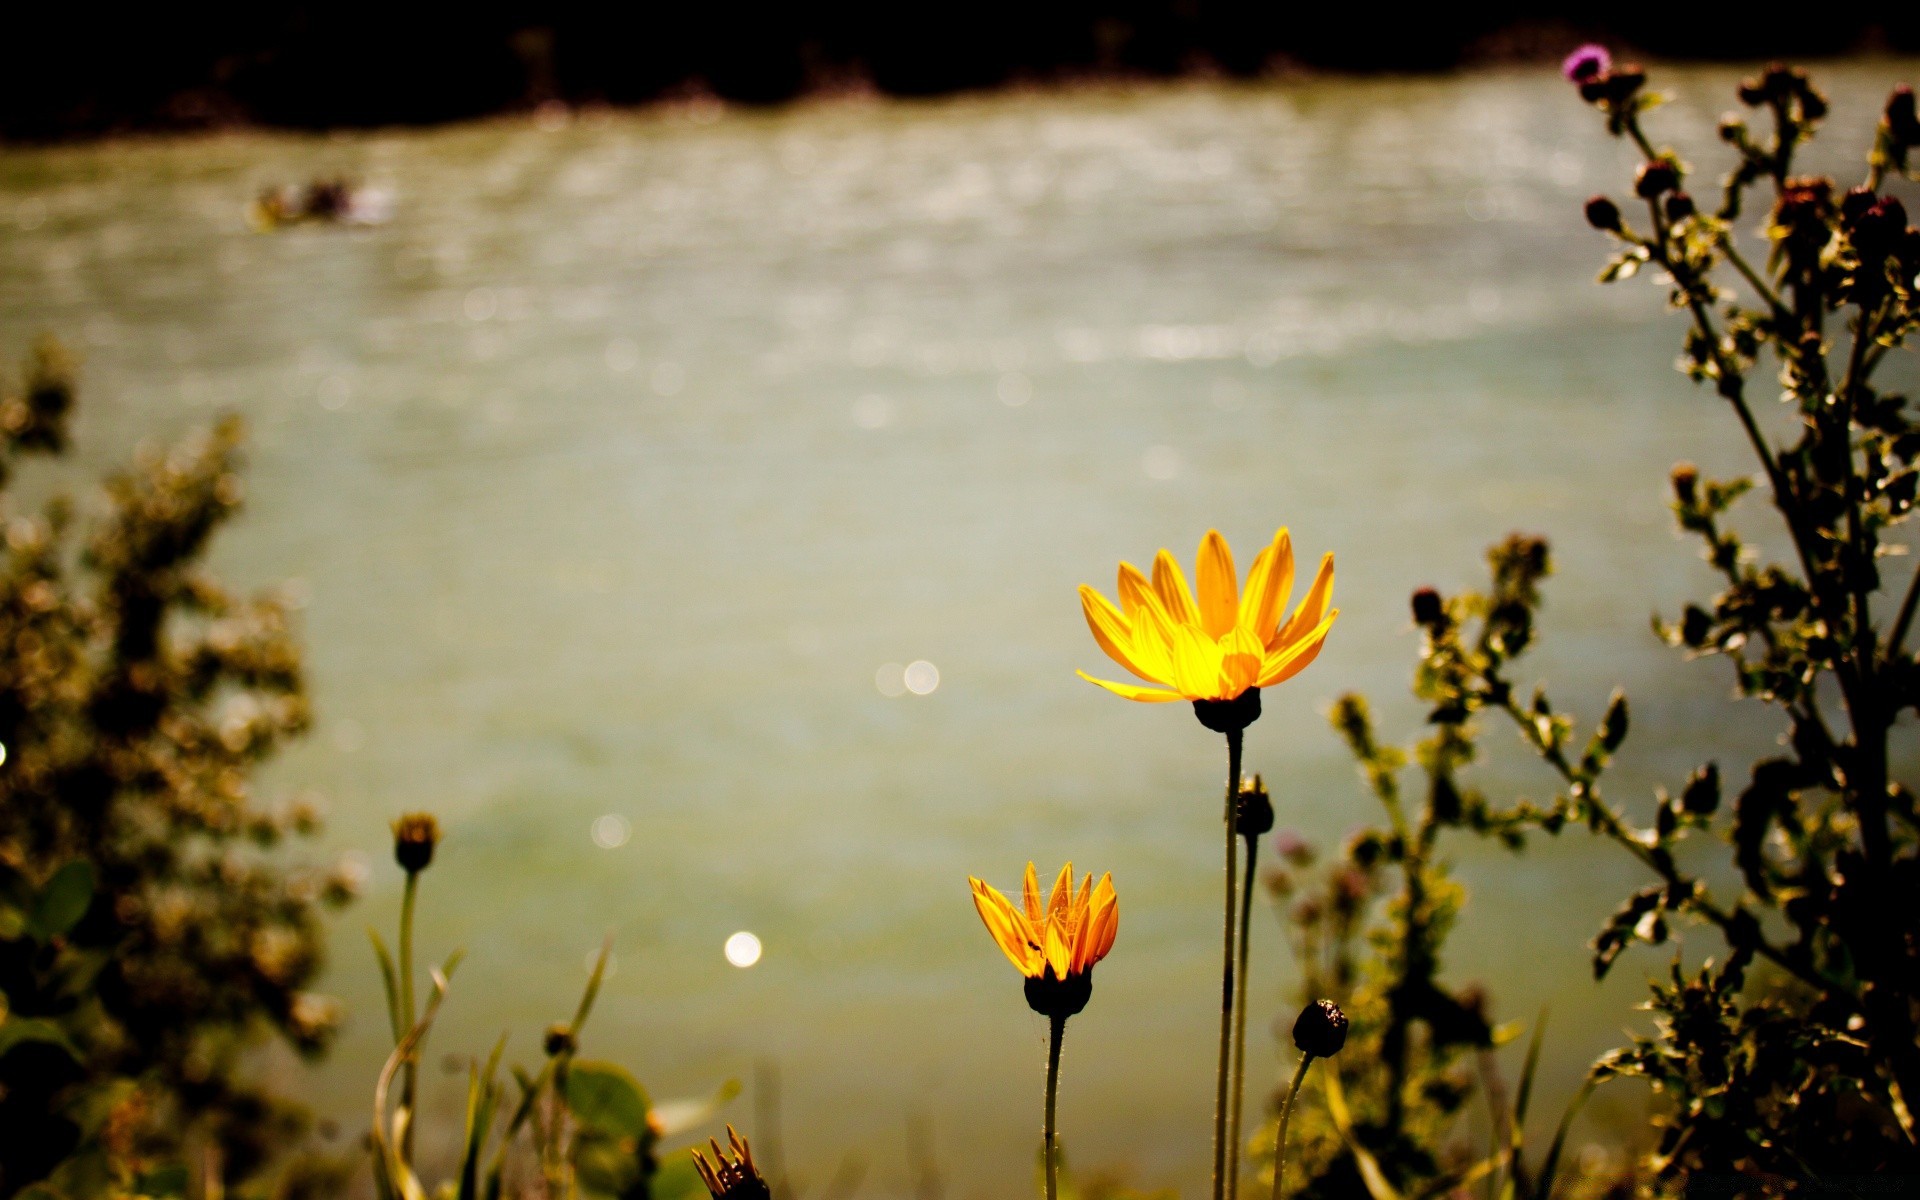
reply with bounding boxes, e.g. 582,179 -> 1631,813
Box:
11,0 -> 1920,140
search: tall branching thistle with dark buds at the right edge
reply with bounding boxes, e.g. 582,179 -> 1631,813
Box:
1296,56 -> 1920,1194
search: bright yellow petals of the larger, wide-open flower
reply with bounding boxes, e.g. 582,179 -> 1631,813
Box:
1077,530 -> 1340,703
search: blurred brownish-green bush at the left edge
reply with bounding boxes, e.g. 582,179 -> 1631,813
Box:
0,340 -> 353,1196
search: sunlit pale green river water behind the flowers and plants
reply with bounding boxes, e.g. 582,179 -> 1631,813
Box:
0,63 -> 1914,1198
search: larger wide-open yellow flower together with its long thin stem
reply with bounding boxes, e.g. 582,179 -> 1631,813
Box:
1079,530 -> 1340,1200
